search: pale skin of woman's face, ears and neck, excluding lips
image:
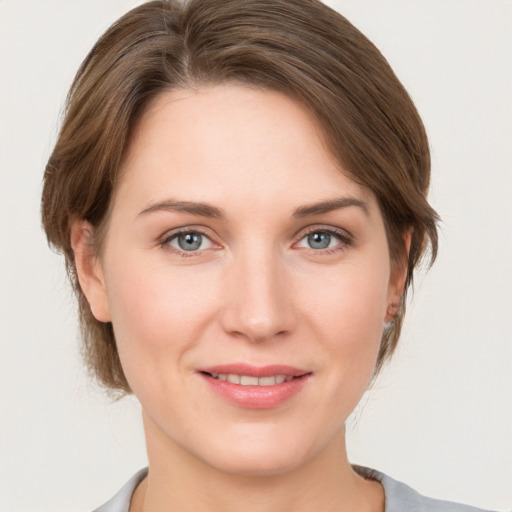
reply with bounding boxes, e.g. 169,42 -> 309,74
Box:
72,84 -> 408,512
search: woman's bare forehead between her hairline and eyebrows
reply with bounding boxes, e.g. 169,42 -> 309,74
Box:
118,84 -> 371,216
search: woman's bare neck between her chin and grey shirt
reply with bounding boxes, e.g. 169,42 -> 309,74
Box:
130,419 -> 384,512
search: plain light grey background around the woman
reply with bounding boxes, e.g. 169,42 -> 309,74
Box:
0,0 -> 512,512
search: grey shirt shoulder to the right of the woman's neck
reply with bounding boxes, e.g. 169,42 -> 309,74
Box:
354,466 -> 490,512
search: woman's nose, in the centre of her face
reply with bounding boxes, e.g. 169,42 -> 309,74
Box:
221,245 -> 297,343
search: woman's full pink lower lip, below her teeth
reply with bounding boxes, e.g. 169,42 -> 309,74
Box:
199,373 -> 311,409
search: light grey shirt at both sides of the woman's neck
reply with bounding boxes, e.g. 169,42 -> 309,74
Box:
94,466 -> 492,512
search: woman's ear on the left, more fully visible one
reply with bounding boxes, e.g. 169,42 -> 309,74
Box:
71,220 -> 111,322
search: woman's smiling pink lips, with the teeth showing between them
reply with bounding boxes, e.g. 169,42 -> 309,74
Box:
197,364 -> 312,409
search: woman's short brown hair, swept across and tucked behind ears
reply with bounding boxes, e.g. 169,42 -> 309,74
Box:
42,0 -> 437,392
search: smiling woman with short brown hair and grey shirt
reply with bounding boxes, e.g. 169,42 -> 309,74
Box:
43,0 -> 496,512
